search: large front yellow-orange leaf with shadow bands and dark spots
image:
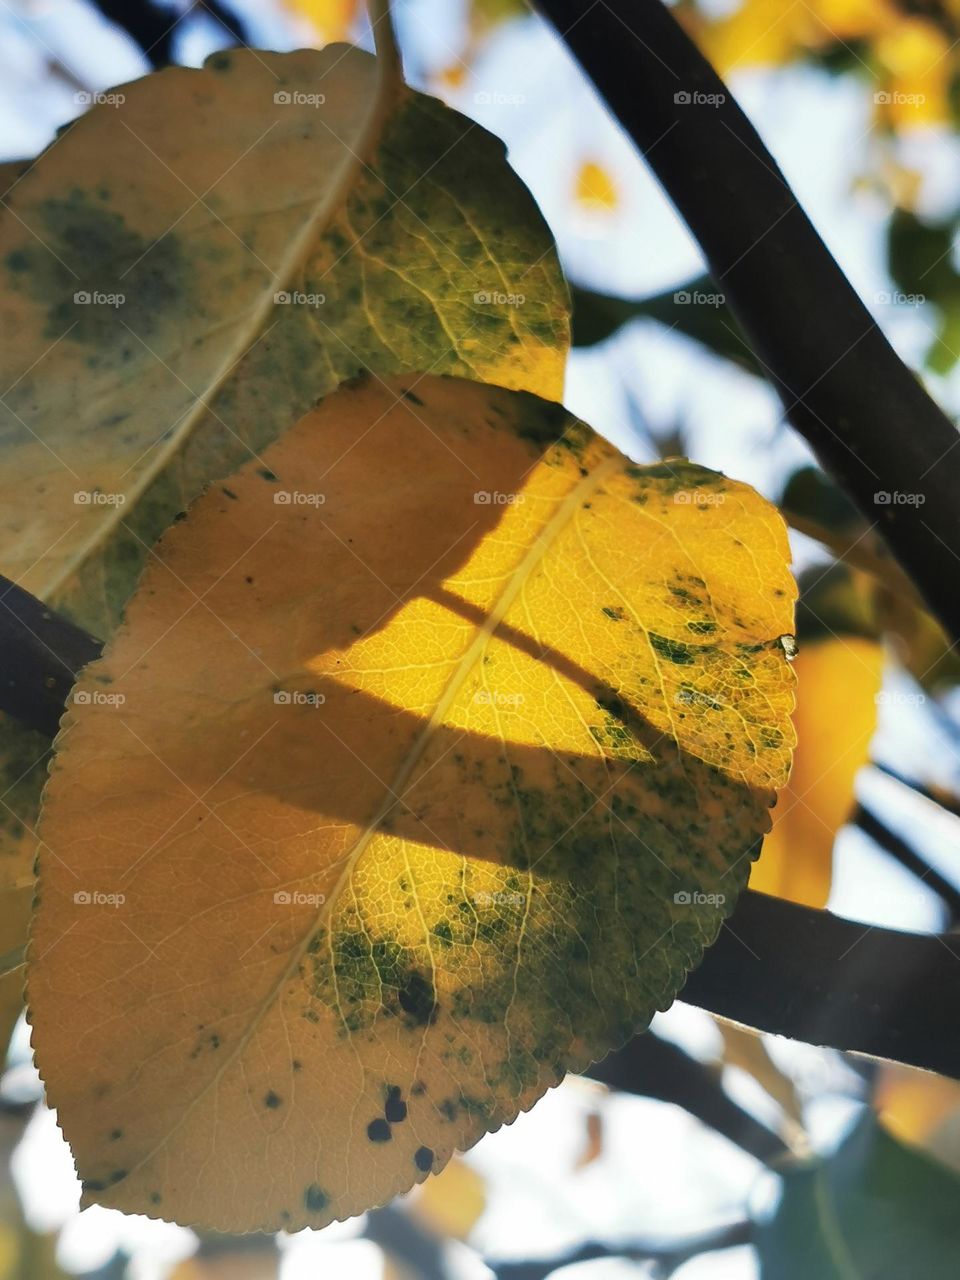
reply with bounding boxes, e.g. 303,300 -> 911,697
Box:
28,375 -> 795,1230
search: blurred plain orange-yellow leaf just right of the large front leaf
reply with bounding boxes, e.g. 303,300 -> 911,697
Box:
750,636 -> 883,906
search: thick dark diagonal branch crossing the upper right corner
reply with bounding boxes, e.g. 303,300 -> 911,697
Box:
539,0 -> 960,640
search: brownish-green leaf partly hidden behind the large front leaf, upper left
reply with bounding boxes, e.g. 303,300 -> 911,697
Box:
0,45 -> 567,962
